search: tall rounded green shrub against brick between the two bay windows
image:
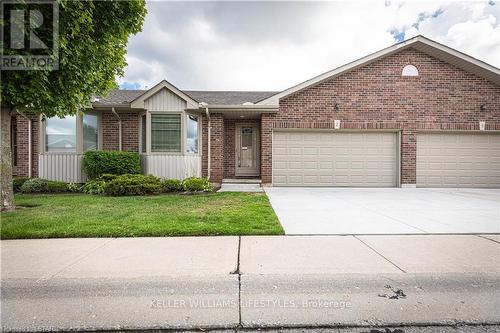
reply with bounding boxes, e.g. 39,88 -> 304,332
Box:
82,150 -> 141,180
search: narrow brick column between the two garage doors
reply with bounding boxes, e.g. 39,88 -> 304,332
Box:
401,126 -> 417,186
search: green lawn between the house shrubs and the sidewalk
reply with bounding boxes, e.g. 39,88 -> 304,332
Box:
0,192 -> 283,239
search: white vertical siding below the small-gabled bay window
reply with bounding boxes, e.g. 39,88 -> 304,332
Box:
141,155 -> 201,179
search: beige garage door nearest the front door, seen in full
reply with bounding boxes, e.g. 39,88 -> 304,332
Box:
273,131 -> 398,186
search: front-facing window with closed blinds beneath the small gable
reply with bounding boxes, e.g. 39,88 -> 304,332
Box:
151,114 -> 181,152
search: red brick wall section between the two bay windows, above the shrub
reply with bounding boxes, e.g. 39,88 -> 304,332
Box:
102,111 -> 139,151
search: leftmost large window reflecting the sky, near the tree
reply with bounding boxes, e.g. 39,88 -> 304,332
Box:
45,116 -> 76,153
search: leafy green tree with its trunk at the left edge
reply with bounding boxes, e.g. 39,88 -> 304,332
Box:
0,0 -> 147,211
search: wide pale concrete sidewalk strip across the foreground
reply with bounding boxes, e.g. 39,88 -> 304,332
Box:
0,235 -> 500,331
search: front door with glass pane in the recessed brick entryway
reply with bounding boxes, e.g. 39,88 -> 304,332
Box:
235,124 -> 260,177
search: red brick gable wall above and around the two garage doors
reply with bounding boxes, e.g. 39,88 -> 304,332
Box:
268,49 -> 500,184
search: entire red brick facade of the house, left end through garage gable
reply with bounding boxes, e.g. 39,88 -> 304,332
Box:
8,48 -> 500,184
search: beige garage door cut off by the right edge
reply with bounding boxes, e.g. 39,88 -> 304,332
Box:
417,133 -> 500,187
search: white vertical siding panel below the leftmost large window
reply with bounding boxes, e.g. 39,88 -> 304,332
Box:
38,153 -> 86,183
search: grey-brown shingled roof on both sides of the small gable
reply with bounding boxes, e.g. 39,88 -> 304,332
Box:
98,90 -> 277,105
